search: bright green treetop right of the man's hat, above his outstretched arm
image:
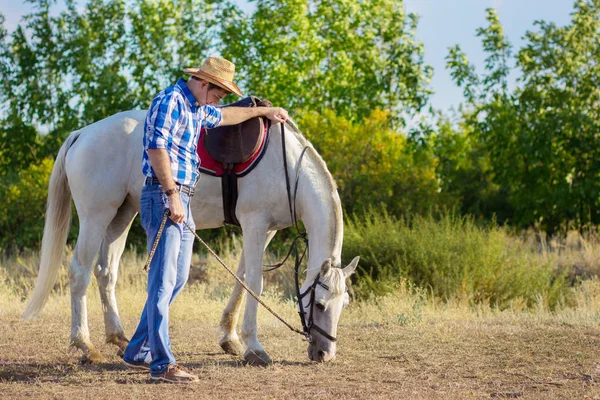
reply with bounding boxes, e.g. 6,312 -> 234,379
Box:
221,0 -> 432,123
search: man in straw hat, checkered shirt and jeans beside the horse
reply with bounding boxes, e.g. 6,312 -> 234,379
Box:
123,57 -> 288,383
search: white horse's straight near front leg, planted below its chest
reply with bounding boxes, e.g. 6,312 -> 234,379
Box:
242,220 -> 273,366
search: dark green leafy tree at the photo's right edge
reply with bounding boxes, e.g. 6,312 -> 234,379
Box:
448,1 -> 600,232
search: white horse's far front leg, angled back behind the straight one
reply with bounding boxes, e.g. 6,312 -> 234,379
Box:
219,231 -> 277,356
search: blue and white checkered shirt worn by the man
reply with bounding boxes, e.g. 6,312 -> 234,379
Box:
142,79 -> 222,186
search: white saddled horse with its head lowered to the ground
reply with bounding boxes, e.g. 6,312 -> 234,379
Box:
24,111 -> 358,364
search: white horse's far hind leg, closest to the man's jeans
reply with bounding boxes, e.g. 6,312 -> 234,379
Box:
94,201 -> 137,356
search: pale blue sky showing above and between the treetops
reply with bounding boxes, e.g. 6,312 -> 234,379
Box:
0,0 -> 574,111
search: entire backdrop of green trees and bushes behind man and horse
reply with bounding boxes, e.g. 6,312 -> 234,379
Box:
0,0 -> 600,308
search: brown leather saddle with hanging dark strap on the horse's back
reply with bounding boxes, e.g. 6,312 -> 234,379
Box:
201,96 -> 271,226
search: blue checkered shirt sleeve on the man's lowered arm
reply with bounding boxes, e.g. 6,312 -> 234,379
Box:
146,93 -> 183,149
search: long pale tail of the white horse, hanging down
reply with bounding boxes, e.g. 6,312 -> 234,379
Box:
23,131 -> 81,319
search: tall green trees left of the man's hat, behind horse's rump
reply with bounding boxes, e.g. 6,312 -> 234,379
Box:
0,0 -> 215,248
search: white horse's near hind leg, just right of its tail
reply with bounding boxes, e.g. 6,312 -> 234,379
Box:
69,215 -> 112,363
